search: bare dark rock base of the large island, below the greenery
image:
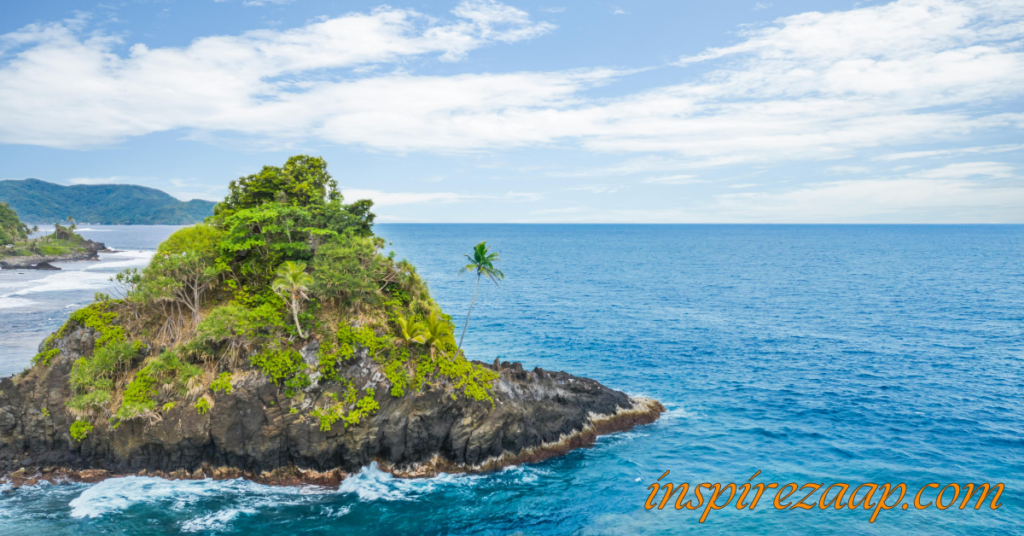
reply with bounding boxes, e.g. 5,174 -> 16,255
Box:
0,328 -> 665,485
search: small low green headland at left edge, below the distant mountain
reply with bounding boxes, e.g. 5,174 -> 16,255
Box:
0,203 -> 106,270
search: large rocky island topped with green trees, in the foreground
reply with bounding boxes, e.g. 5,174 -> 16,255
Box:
0,157 -> 664,486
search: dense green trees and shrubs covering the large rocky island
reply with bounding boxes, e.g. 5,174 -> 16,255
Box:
35,156 -> 497,440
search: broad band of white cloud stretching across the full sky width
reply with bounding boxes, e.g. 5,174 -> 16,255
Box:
0,0 -> 1024,170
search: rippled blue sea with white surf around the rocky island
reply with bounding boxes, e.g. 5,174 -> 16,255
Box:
0,224 -> 1024,536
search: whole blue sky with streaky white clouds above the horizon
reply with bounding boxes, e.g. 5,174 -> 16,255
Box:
0,0 -> 1024,223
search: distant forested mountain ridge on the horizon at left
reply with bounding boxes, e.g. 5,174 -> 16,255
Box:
0,178 -> 216,225
